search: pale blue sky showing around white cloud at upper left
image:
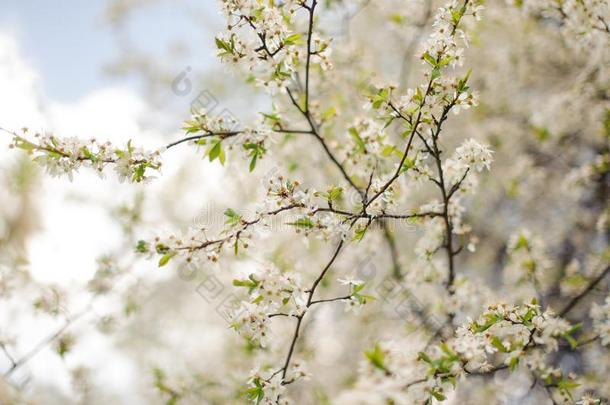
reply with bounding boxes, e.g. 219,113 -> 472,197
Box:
0,0 -> 221,102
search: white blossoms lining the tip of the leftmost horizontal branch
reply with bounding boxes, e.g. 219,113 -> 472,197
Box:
11,128 -> 161,183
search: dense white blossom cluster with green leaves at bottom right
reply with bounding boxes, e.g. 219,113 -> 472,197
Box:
419,300 -> 579,399
